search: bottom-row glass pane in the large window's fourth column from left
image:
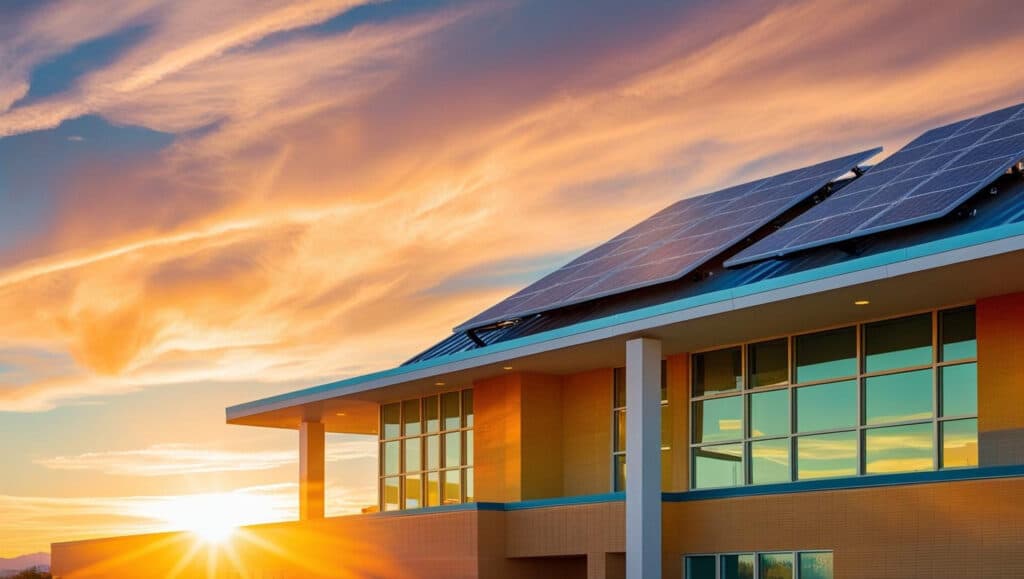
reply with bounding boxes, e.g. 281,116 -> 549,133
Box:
864,422 -> 935,474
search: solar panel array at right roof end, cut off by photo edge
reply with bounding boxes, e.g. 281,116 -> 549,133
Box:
725,104 -> 1024,266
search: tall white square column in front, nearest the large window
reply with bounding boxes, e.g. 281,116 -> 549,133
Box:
626,338 -> 662,579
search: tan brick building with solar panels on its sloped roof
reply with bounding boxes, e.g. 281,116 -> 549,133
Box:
53,105 -> 1024,579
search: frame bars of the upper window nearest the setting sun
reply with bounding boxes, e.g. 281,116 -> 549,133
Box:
378,388 -> 475,511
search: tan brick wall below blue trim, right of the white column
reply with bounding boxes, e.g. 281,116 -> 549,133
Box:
663,479 -> 1024,579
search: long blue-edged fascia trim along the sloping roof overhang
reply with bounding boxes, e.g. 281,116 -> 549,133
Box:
227,221 -> 1024,414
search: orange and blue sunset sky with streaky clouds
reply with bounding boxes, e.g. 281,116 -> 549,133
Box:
0,0 -> 1024,556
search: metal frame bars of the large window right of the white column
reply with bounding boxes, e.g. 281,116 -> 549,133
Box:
687,304 -> 978,489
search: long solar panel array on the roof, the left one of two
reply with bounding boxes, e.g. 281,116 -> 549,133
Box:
456,148 -> 882,331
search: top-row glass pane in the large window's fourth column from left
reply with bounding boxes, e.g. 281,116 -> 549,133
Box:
864,314 -> 932,372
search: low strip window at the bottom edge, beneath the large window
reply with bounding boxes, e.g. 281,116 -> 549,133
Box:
683,550 -> 833,579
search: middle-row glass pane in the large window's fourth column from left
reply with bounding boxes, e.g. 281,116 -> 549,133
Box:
864,369 -> 933,424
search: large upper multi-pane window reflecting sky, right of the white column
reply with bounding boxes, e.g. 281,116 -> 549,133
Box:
690,306 -> 978,487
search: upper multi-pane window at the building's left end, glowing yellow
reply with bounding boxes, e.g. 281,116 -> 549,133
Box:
380,389 -> 474,510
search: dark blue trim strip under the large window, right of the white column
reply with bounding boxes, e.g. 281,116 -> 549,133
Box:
662,464 -> 1024,502
